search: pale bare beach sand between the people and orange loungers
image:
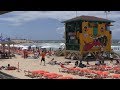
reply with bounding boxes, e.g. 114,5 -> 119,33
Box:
0,55 -> 116,79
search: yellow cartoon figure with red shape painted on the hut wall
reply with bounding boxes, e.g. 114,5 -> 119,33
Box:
83,22 -> 108,51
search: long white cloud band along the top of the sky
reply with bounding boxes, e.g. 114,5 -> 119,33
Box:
0,11 -> 116,25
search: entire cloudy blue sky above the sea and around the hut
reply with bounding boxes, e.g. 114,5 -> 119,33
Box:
0,11 -> 120,40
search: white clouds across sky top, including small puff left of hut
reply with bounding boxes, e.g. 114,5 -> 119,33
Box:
0,11 -> 120,38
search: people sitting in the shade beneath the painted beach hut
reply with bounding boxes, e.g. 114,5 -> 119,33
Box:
75,51 -> 120,68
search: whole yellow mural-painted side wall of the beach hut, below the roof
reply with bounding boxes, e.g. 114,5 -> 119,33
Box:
79,21 -> 111,52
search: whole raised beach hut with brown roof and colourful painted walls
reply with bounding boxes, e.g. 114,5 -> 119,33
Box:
63,15 -> 114,58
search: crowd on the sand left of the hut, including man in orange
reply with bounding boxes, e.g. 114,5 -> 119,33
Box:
15,48 -> 54,66
